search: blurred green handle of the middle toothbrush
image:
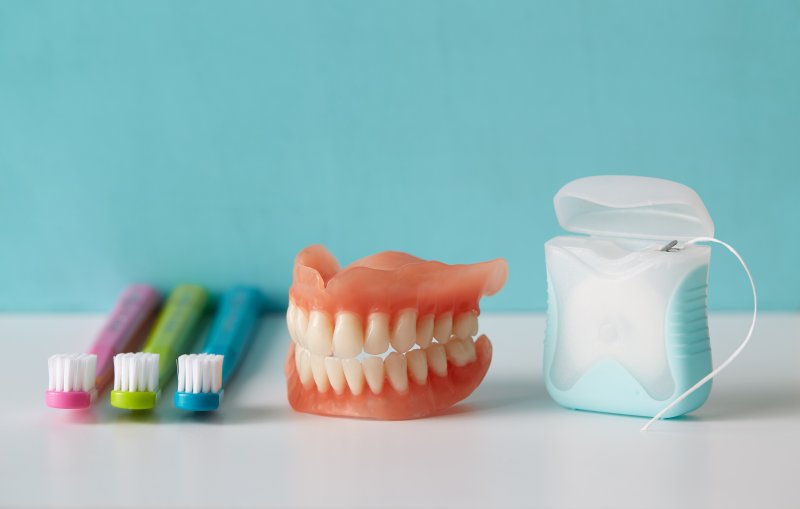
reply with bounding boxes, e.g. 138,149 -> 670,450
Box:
144,285 -> 208,387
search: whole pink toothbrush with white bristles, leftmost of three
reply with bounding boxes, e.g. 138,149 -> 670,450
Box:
45,285 -> 160,410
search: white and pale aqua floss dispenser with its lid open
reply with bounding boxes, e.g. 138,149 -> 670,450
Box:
544,176 -> 713,417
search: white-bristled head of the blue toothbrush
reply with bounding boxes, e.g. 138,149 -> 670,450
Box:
174,353 -> 225,412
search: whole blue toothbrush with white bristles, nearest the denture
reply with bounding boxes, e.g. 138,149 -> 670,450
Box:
174,286 -> 262,412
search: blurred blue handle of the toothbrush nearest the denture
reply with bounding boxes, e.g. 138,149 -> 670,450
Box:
205,286 -> 263,380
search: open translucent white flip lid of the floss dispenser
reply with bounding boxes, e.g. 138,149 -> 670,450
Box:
553,175 -> 714,241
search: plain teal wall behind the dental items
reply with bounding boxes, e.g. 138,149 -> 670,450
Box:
0,0 -> 800,311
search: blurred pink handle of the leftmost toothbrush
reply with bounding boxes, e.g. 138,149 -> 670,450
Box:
89,285 -> 160,390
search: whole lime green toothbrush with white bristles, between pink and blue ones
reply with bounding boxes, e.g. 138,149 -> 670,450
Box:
111,285 -> 208,410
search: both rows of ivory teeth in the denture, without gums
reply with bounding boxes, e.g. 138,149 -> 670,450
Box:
294,308 -> 478,396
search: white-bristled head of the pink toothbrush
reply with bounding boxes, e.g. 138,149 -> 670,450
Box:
45,353 -> 97,410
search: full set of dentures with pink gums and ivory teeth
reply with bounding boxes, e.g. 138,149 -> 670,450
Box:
286,245 -> 508,420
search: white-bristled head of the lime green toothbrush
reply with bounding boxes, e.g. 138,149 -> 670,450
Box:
111,352 -> 159,410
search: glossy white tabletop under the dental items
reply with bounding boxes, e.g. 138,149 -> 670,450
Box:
0,314 -> 800,509
